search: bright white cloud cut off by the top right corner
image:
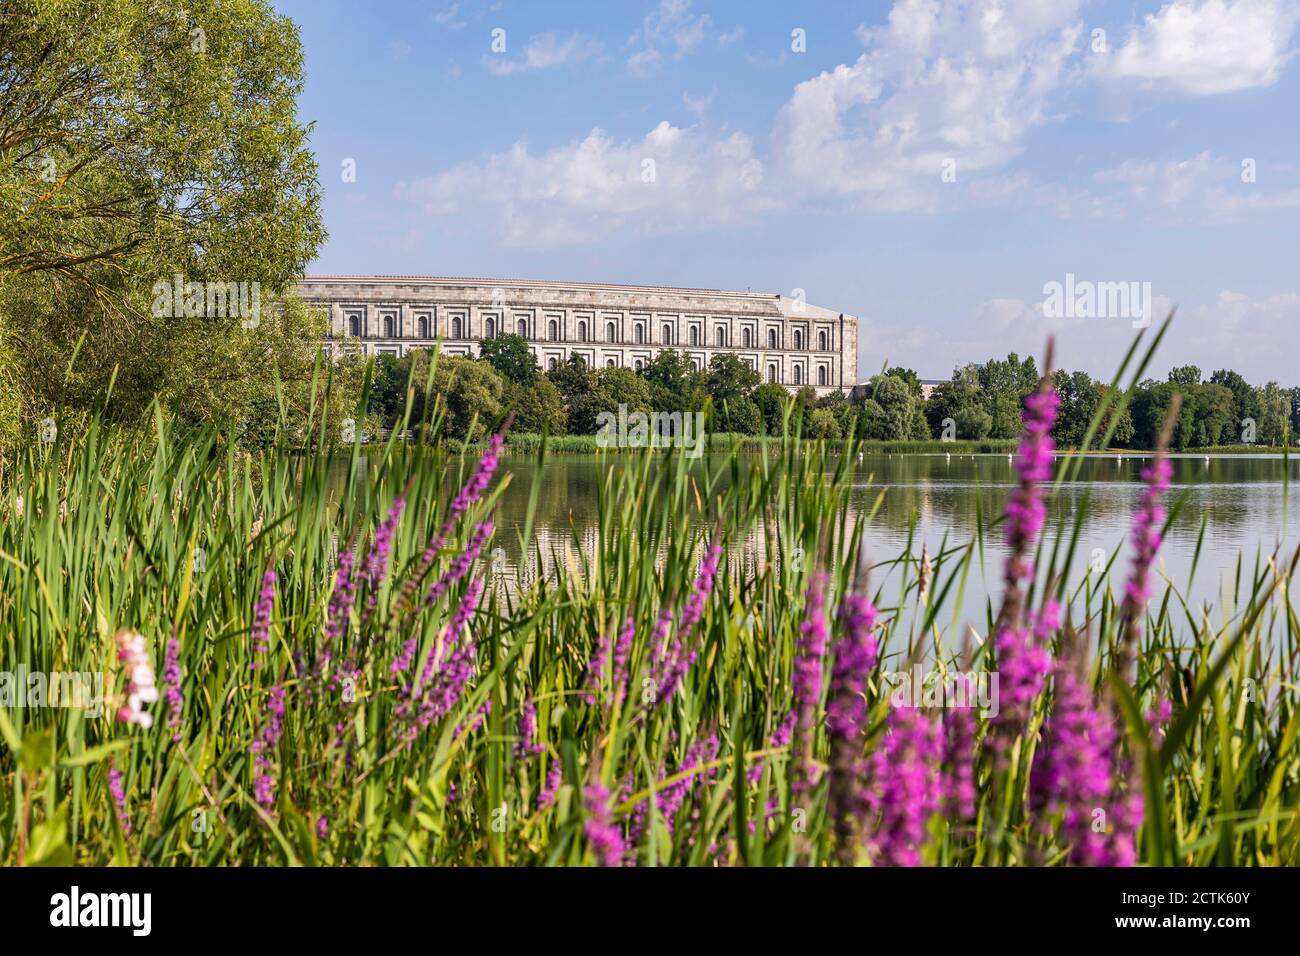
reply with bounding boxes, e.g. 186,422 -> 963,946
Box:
1092,0 -> 1300,96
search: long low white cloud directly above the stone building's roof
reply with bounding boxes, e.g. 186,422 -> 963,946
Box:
397,122 -> 772,248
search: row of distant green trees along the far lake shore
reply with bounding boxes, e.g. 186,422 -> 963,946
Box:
368,336 -> 1300,449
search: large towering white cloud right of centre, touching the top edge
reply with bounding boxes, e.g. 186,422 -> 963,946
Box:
774,0 -> 1082,212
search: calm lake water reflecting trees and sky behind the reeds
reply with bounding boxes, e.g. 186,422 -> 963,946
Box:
488,454 -> 1300,622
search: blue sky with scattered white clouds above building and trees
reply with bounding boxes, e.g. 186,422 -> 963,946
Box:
274,0 -> 1300,385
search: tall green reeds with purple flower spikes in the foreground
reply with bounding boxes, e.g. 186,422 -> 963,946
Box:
0,323 -> 1300,866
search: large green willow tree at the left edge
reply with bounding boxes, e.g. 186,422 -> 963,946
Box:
0,0 -> 324,439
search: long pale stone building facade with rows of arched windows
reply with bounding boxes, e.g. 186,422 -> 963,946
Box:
298,276 -> 858,395
